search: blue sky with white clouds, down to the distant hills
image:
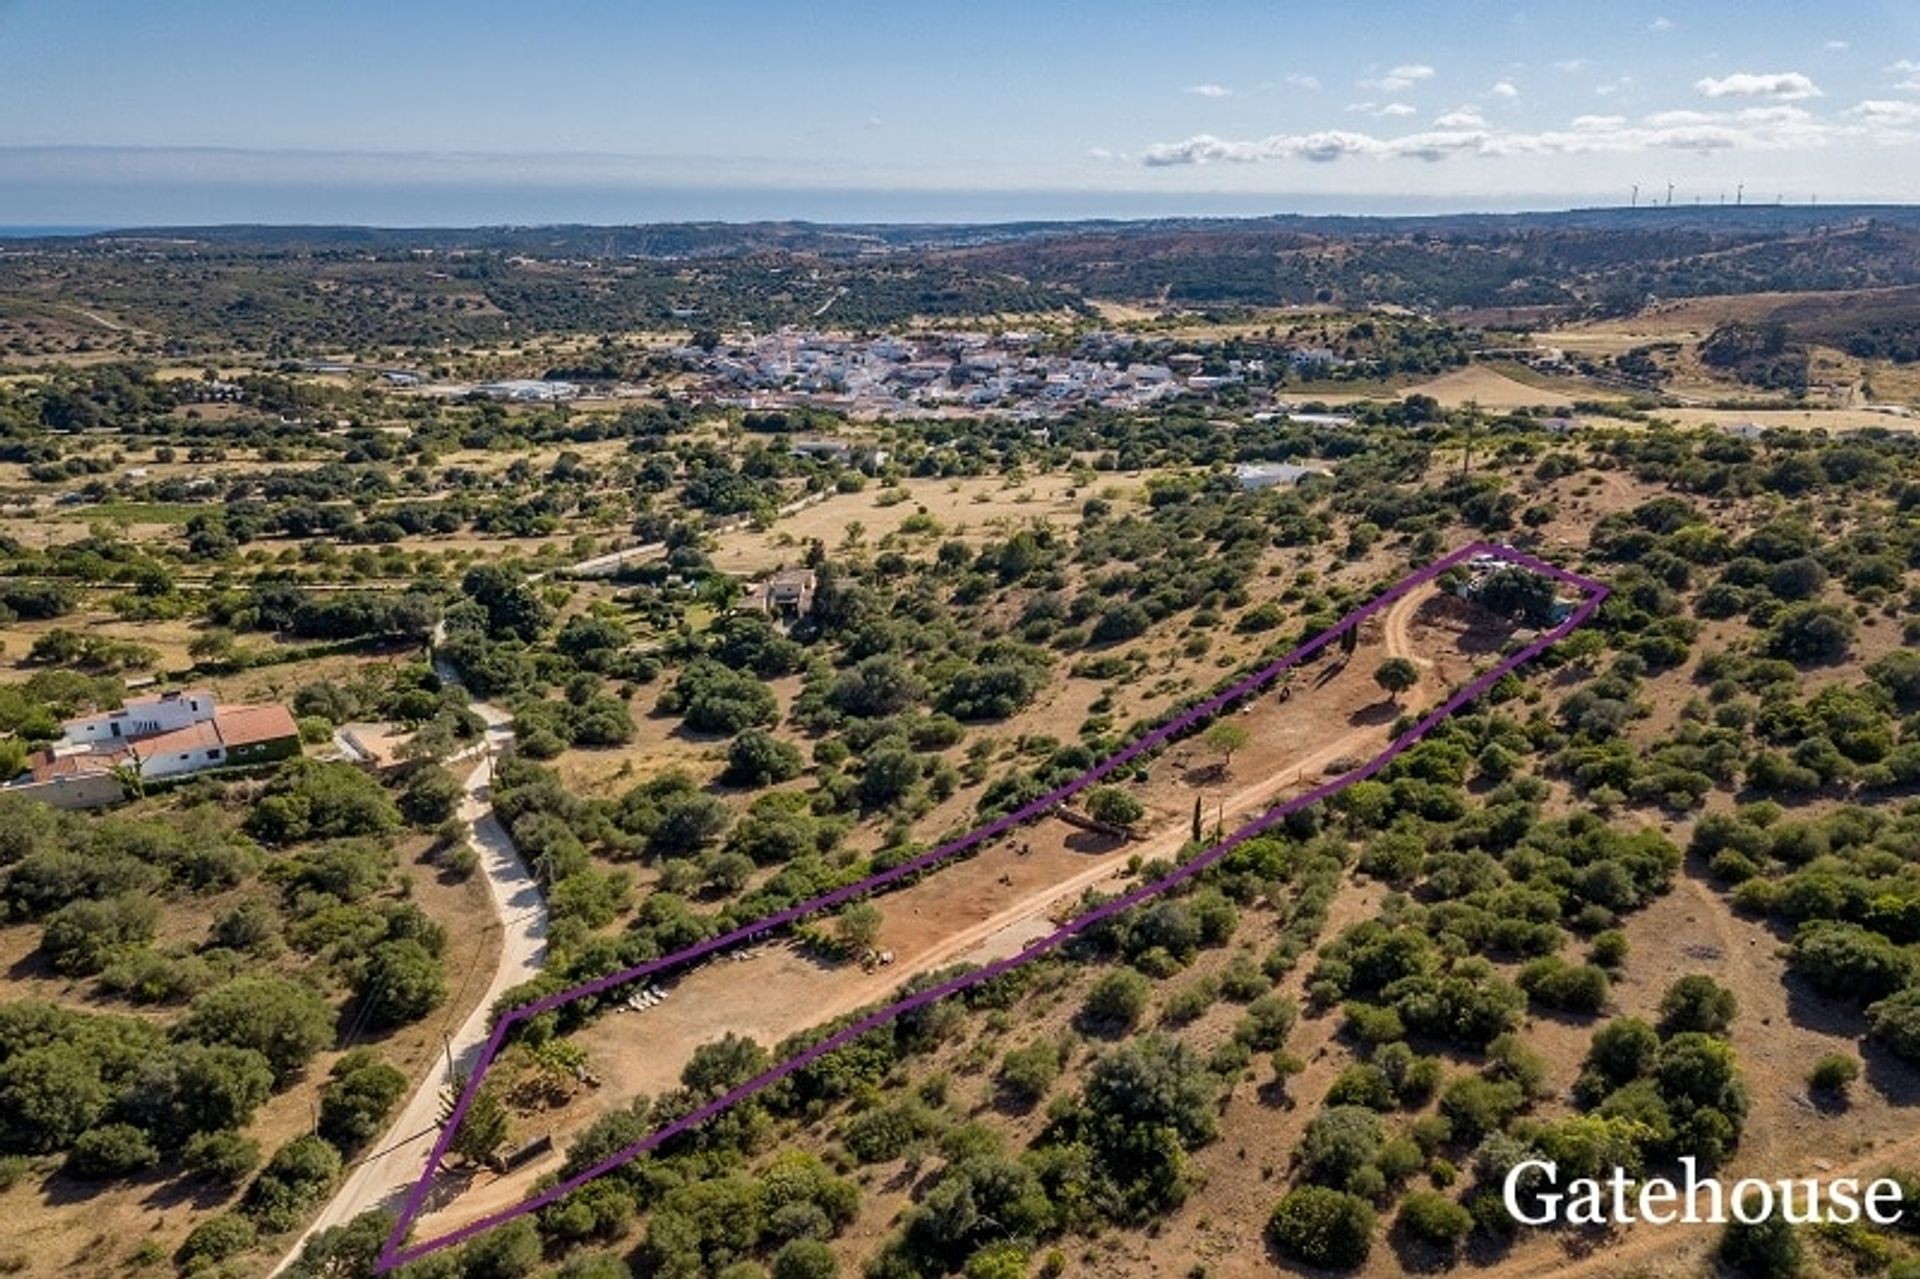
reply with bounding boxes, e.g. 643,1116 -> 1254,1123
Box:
11,0 -> 1920,227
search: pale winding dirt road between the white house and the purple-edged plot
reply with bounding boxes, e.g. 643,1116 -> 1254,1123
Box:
273,652 -> 547,1275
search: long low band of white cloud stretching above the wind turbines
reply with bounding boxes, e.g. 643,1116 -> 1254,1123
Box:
1140,102 -> 1889,167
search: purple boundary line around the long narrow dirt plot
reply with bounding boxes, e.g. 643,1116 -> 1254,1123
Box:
374,542 -> 1609,1275
